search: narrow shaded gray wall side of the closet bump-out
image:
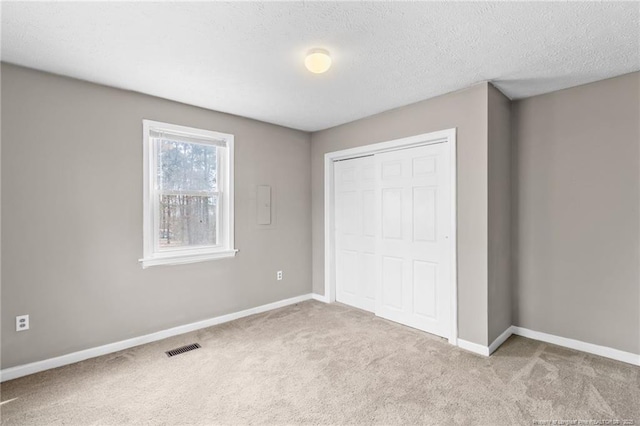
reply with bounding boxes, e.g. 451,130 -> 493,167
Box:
487,84 -> 513,343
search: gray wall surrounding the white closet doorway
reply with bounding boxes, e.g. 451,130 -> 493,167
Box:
311,83 -> 488,345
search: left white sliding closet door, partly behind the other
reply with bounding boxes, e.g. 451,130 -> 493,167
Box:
334,156 -> 376,312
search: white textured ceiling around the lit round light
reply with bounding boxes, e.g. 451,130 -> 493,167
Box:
2,2 -> 640,131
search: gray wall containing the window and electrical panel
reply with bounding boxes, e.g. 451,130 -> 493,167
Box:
2,64 -> 311,368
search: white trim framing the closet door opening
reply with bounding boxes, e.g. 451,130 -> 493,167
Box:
324,128 -> 458,345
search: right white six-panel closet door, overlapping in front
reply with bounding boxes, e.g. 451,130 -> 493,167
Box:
374,144 -> 452,337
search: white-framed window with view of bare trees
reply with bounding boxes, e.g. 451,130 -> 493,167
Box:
140,120 -> 237,268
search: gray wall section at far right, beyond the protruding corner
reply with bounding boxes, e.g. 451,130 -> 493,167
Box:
514,73 -> 640,353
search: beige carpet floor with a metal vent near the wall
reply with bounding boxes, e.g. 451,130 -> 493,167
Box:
0,301 -> 640,425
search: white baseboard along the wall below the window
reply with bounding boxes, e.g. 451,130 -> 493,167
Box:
0,294 -> 318,382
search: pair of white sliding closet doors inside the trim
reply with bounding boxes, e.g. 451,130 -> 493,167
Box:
334,144 -> 454,337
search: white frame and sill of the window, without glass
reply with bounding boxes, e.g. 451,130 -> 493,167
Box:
139,120 -> 238,268
